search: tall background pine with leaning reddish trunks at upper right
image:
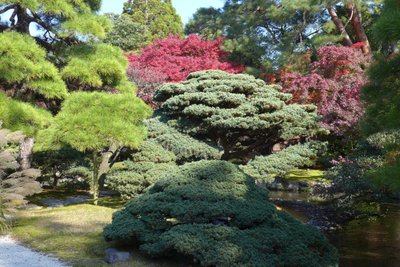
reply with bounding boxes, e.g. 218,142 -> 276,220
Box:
185,0 -> 380,68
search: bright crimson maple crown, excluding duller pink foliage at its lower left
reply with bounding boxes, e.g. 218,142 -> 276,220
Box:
128,34 -> 244,82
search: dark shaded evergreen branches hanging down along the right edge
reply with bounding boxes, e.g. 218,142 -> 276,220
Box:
363,0 -> 400,192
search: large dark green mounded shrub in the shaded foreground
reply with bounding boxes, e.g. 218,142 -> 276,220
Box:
104,161 -> 338,267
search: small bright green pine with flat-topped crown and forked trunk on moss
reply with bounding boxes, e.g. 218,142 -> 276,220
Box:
36,92 -> 151,204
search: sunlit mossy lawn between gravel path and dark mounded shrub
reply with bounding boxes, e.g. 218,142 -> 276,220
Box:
12,204 -> 190,267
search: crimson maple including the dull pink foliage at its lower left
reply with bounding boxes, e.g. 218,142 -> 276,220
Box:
128,34 -> 244,108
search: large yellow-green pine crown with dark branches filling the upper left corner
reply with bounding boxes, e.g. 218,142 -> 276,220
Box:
0,0 -> 132,100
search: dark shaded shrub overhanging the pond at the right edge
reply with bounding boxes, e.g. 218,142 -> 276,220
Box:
315,130 -> 400,206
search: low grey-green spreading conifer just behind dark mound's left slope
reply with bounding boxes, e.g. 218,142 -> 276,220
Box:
107,117 -> 221,198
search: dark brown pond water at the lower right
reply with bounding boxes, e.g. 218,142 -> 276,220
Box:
270,192 -> 400,267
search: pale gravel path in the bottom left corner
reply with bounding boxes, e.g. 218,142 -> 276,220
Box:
0,236 -> 68,267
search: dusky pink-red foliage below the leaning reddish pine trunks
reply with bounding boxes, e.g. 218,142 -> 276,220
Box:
281,46 -> 370,135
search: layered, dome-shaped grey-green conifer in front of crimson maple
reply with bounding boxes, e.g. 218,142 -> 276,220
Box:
155,70 -> 320,163
